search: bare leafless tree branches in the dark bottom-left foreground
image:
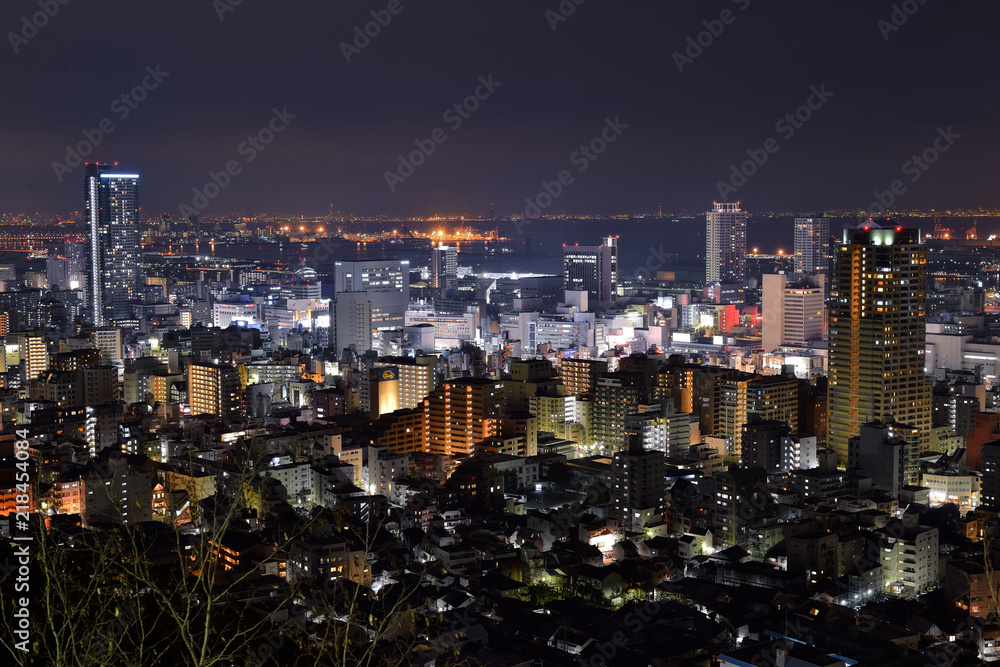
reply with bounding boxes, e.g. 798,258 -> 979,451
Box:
0,444 -> 470,667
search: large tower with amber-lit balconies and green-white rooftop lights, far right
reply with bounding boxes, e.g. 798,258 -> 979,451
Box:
828,223 -> 932,463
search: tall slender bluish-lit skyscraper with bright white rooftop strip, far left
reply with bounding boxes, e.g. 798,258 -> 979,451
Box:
84,164 -> 139,326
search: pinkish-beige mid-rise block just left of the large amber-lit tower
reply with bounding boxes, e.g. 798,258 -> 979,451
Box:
761,273 -> 826,352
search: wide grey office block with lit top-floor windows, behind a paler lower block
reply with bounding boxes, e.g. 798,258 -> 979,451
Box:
333,259 -> 410,330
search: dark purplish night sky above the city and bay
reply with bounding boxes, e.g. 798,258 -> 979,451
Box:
0,0 -> 1000,215
